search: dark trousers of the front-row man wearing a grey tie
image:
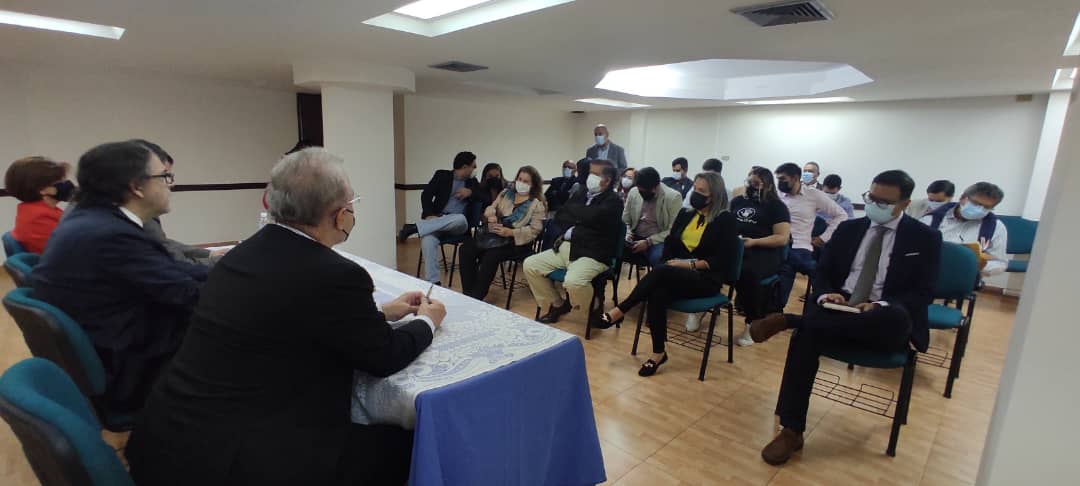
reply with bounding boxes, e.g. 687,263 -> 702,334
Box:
777,302 -> 912,432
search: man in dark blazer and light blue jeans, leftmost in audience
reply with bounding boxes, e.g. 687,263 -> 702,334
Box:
397,152 -> 480,285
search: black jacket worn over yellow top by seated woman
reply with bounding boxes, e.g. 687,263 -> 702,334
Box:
661,210 -> 739,285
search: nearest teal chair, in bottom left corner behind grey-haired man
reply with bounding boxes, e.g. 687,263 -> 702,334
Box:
0,357 -> 135,486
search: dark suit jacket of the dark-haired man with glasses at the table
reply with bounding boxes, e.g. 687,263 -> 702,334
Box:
30,207 -> 207,414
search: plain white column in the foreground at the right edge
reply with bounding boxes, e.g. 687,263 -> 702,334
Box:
976,87 -> 1080,486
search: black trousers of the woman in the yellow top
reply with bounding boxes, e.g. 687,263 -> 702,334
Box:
619,265 -> 723,353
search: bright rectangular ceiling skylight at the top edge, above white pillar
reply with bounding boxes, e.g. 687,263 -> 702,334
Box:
364,0 -> 573,37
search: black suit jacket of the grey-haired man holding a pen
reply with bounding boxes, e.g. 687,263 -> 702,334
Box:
127,225 -> 432,485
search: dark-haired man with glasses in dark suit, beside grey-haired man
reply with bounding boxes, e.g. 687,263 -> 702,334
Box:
30,141 -> 207,415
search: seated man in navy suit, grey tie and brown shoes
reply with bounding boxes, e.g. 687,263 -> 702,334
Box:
751,171 -> 942,465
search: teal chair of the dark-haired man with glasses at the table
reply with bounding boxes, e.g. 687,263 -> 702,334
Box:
3,288 -> 134,431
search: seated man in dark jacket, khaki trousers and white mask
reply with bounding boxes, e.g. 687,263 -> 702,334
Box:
523,160 -> 622,324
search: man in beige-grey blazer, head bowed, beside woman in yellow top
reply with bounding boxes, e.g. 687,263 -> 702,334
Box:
622,167 -> 683,267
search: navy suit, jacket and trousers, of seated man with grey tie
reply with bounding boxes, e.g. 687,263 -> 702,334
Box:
777,215 -> 942,432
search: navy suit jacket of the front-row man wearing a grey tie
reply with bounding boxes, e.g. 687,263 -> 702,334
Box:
807,215 -> 942,352
